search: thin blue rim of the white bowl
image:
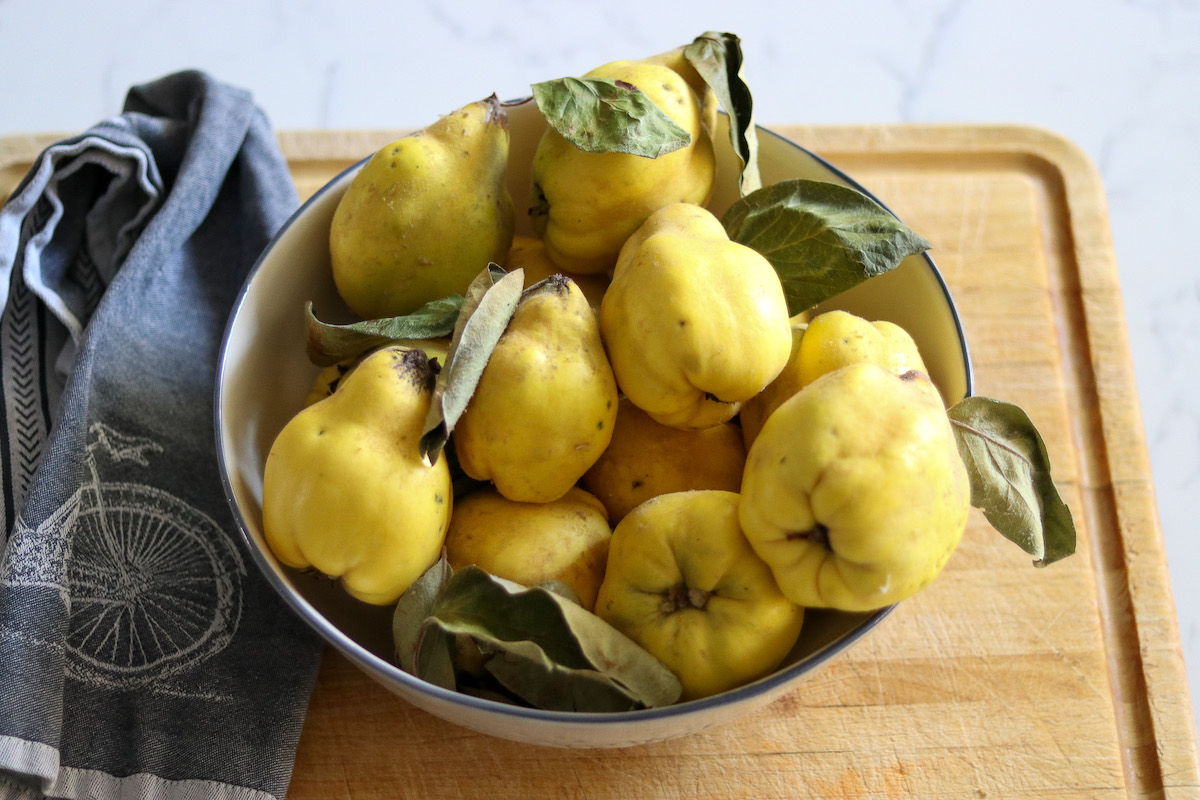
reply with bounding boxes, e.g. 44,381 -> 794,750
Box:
214,127 -> 974,726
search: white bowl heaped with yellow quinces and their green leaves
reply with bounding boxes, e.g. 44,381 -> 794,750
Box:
216,32 -> 1074,747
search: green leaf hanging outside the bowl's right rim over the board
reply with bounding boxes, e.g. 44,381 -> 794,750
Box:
948,397 -> 1075,566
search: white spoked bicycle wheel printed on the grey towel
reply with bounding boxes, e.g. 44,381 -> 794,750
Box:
66,483 -> 245,688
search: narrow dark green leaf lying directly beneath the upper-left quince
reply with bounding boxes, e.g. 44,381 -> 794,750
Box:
305,294 -> 462,367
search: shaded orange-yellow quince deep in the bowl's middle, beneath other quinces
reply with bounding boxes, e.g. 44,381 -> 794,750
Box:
582,397 -> 746,524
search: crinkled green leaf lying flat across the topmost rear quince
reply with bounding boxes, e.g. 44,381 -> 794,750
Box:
533,78 -> 691,158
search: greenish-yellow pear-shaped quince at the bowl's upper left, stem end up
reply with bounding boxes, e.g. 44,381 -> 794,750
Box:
329,96 -> 515,319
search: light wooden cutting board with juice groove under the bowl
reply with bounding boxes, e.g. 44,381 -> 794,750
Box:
0,126 -> 1200,800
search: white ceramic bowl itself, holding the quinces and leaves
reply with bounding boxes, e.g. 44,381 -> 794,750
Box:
215,102 -> 971,747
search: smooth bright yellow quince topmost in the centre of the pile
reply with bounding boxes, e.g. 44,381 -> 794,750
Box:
600,203 -> 792,428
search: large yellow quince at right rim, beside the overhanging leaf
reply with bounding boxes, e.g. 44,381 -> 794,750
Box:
739,362 -> 971,612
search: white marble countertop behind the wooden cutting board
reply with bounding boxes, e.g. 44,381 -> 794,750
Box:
0,0 -> 1200,738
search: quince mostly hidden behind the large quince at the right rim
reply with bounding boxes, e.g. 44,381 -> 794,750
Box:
739,309 -> 929,449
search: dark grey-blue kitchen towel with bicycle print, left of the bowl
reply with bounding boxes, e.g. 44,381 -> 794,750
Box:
0,71 -> 320,799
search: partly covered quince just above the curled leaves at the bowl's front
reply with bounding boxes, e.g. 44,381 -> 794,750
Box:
446,487 -> 612,610
